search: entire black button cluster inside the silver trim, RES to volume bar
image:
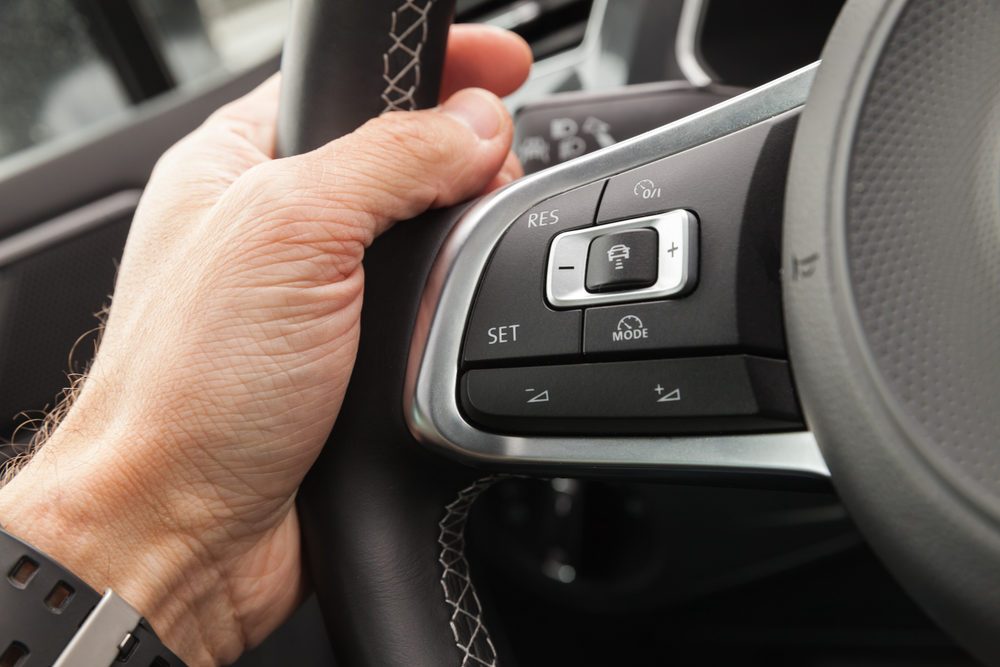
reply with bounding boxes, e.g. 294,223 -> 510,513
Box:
456,113 -> 803,435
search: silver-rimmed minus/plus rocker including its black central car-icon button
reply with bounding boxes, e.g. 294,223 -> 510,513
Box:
545,210 -> 698,308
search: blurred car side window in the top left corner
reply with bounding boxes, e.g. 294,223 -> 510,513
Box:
0,0 -> 289,160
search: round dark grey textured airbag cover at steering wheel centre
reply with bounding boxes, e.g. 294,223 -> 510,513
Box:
783,0 -> 1000,663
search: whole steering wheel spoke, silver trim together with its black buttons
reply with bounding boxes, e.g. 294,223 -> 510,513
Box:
404,67 -> 828,486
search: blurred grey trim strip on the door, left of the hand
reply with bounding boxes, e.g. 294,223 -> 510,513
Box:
0,190 -> 142,269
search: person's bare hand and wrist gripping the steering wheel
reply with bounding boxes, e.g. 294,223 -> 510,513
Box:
0,27 -> 531,665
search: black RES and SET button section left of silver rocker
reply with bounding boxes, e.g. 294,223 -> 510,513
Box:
464,181 -> 604,363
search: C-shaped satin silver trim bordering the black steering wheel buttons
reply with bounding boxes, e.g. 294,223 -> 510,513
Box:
403,64 -> 829,478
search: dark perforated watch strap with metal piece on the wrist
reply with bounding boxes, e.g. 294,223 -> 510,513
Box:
0,528 -> 184,667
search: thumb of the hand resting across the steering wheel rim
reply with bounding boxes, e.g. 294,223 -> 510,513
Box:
234,88 -> 513,246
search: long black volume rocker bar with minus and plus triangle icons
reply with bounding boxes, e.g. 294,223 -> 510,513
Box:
461,355 -> 801,434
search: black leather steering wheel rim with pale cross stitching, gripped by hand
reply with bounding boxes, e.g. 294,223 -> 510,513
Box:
277,0 -> 496,667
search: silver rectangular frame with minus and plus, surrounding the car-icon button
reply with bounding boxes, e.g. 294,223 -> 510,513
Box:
545,210 -> 698,308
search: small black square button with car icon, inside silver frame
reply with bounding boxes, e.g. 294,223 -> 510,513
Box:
586,227 -> 659,292
